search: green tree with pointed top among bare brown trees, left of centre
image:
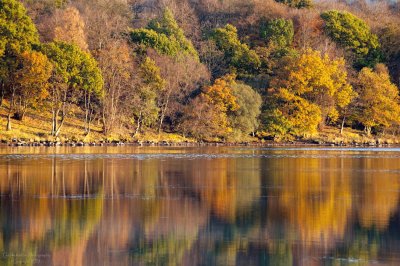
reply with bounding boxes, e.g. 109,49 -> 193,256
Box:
130,8 -> 199,60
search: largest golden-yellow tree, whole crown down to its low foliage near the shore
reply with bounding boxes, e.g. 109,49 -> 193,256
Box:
265,50 -> 355,136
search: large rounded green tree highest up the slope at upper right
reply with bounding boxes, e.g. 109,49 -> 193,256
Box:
321,10 -> 381,68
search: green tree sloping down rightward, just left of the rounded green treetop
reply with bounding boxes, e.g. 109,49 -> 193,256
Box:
210,24 -> 261,74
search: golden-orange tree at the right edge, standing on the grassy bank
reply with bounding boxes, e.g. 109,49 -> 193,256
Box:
356,64 -> 400,135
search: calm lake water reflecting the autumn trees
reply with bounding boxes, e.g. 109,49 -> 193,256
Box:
0,147 -> 400,266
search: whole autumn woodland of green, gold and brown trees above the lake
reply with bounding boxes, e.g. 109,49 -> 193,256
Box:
0,0 -> 400,142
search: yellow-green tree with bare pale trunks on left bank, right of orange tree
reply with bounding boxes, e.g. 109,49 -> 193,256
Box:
40,42 -> 103,136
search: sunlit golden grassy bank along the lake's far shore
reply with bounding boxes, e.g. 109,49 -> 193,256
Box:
0,104 -> 400,146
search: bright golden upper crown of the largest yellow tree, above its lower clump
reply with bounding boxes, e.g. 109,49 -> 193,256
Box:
275,49 -> 356,121
